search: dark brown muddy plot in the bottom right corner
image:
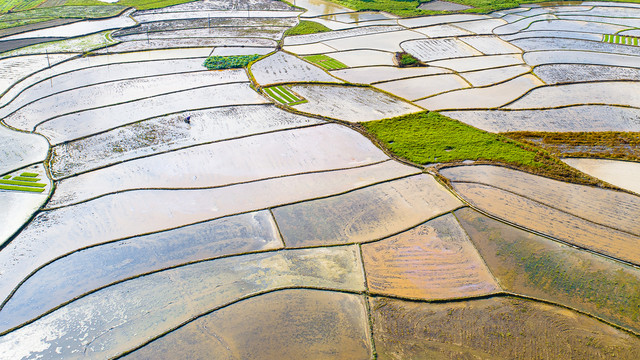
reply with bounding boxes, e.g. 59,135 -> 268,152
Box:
370,298 -> 640,359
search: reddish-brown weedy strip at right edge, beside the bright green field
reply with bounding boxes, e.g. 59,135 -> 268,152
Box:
503,131 -> 640,161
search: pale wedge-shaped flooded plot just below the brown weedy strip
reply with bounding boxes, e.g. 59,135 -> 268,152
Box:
562,158 -> 640,194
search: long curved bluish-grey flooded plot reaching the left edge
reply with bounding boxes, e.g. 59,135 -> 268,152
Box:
0,211 -> 282,331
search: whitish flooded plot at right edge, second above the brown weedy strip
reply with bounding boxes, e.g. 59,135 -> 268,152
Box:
505,81 -> 640,109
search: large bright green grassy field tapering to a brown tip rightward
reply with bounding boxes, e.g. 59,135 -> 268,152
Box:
362,111 -> 597,184
